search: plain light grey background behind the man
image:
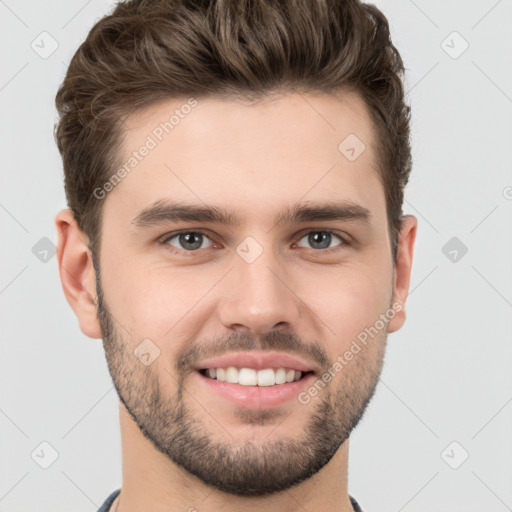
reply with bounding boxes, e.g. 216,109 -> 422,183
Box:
0,0 -> 512,512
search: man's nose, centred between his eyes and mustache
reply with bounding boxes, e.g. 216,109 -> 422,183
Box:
219,251 -> 301,336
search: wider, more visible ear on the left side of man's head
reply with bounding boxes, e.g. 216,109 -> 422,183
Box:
55,209 -> 102,338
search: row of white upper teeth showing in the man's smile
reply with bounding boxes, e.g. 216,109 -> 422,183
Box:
202,366 -> 302,386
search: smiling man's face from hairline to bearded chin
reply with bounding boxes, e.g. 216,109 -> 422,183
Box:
89,93 -> 408,496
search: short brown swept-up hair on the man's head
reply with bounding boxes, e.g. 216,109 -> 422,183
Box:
55,0 -> 412,260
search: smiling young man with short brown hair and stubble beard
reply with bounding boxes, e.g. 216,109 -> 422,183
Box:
56,0 -> 417,512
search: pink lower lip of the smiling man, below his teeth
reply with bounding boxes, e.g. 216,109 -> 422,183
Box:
194,371 -> 315,409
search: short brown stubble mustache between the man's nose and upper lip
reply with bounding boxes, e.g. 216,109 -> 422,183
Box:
175,331 -> 329,375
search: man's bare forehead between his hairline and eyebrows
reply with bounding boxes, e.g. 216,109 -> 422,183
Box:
104,92 -> 385,227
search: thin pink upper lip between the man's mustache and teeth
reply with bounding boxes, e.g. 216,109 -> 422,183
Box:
194,351 -> 314,372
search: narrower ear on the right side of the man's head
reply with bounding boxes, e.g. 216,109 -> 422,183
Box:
388,215 -> 418,333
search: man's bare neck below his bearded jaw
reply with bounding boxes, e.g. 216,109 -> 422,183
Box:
115,404 -> 353,512
